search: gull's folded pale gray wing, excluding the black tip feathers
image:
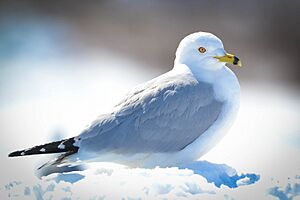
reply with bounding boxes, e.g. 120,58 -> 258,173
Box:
79,71 -> 223,153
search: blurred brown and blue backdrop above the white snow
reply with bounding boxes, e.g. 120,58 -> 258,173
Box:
0,0 -> 300,87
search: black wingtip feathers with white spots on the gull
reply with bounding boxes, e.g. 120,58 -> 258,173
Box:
8,137 -> 79,157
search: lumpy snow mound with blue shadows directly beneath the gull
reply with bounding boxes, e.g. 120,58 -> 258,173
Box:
0,161 -> 259,199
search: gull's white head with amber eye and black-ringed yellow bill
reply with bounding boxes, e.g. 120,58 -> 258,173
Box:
175,32 -> 242,70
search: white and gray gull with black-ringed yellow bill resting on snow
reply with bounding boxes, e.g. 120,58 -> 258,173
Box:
9,32 -> 241,174
